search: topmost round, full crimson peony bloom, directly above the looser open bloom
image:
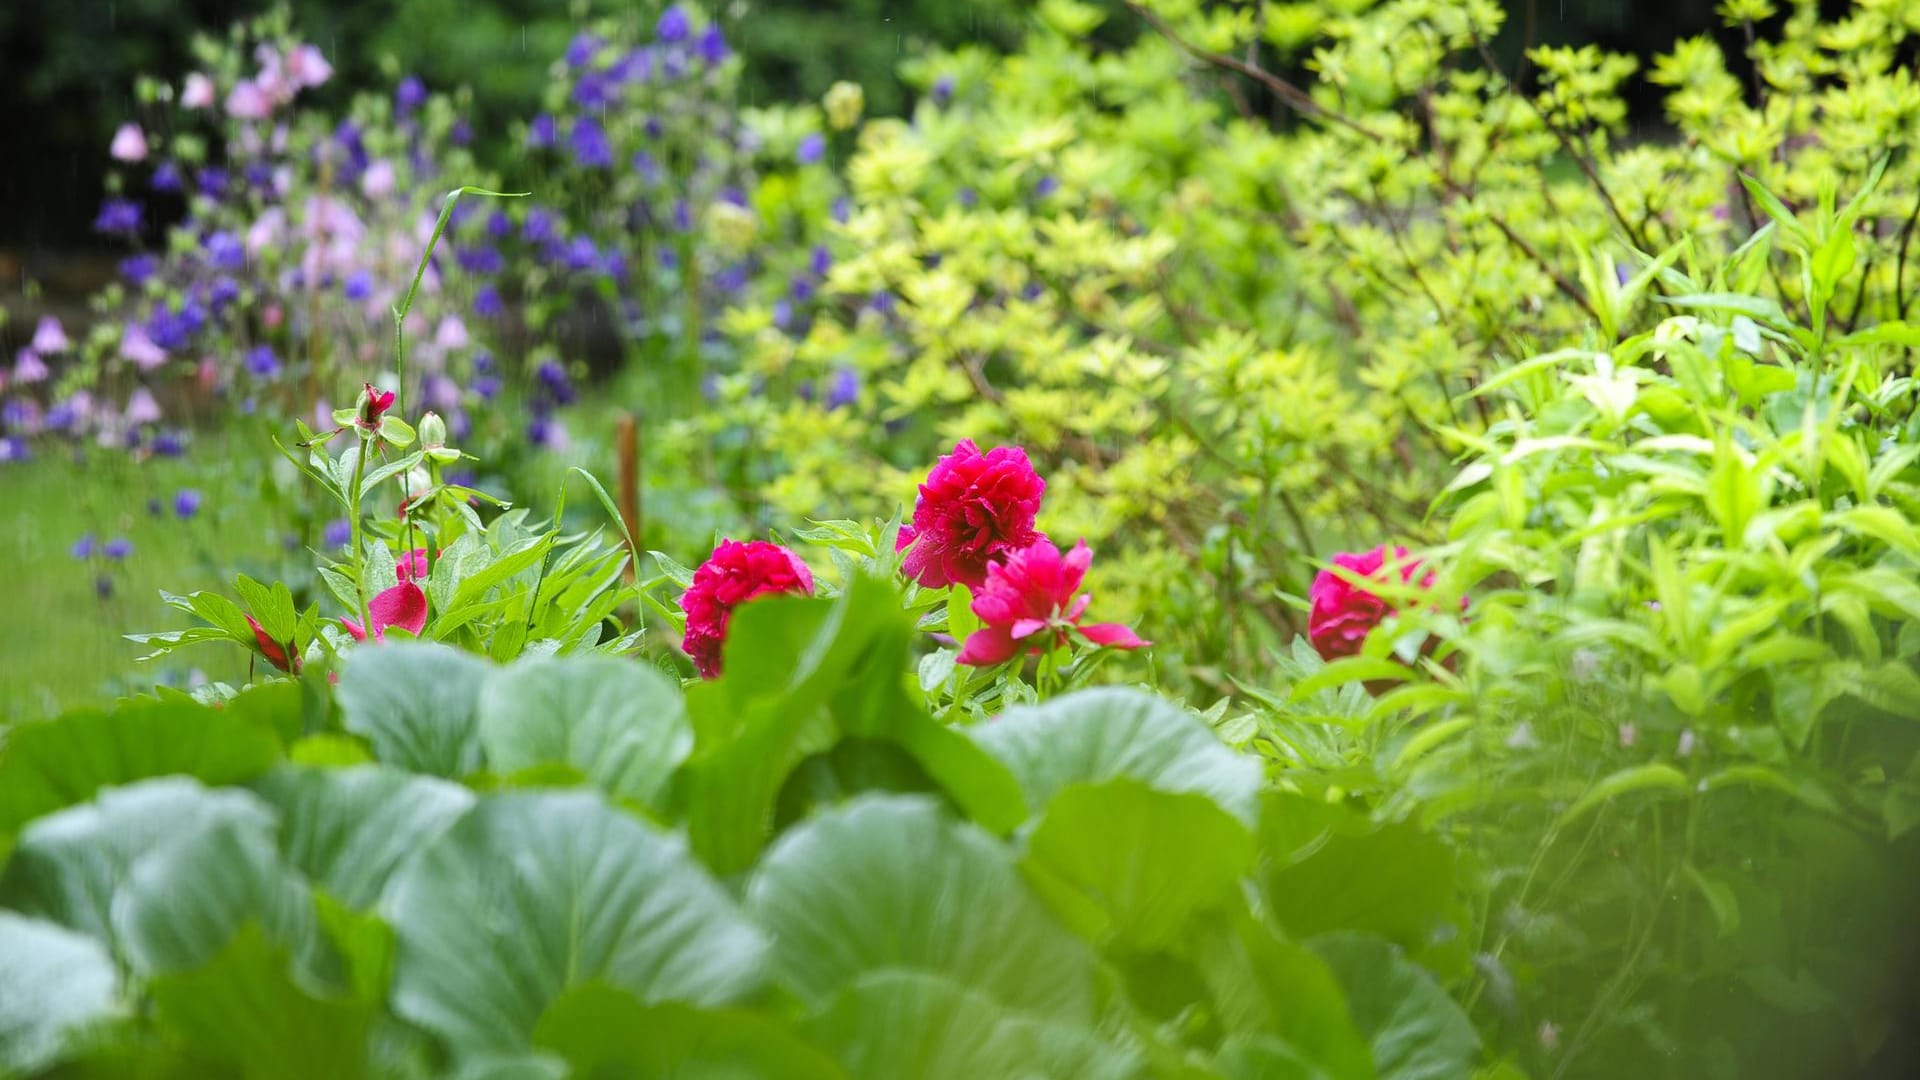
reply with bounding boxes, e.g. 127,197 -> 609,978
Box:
899,438 -> 1046,588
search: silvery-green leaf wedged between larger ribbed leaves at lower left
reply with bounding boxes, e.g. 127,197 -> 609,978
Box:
255,765 -> 474,907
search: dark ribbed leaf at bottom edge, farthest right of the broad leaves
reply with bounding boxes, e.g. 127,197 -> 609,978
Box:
1308,932 -> 1480,1080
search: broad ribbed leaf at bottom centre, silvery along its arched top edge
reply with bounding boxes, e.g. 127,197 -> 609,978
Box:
747,796 -> 1092,1020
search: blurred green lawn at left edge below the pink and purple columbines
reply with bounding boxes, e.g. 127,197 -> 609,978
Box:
0,426 -> 286,721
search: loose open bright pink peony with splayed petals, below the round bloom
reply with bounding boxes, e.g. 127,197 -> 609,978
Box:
958,540 -> 1148,667
